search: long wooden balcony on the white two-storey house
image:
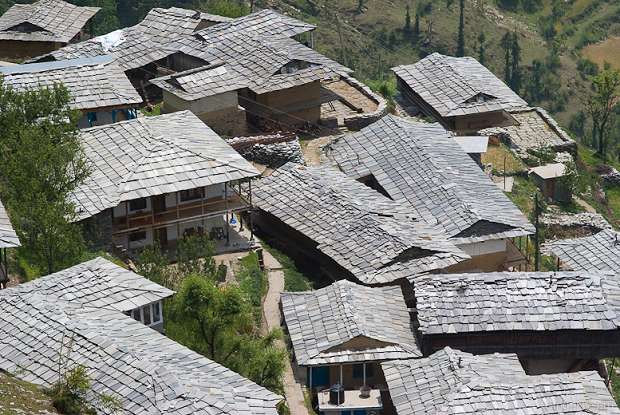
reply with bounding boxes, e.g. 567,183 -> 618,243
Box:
113,194 -> 250,233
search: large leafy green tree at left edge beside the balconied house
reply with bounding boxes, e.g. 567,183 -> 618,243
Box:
0,81 -> 89,273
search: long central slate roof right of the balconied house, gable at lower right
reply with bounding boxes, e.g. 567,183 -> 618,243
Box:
253,163 -> 469,284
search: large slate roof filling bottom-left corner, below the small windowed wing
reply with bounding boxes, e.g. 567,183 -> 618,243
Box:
0,289 -> 282,415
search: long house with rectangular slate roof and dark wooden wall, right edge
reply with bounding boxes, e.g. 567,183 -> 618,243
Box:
412,271 -> 620,374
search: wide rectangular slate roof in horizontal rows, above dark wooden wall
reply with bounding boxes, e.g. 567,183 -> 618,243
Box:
414,271 -> 620,334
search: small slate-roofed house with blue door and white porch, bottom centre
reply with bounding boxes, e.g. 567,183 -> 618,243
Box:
281,280 -> 421,415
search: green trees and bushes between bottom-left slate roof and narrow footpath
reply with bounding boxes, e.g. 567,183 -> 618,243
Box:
138,235 -> 287,393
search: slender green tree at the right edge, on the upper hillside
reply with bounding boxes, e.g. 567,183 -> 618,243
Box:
585,69 -> 620,160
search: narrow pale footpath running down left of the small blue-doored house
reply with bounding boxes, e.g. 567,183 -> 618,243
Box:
263,251 -> 308,415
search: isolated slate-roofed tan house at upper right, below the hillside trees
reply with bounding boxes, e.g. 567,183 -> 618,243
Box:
392,53 -> 528,134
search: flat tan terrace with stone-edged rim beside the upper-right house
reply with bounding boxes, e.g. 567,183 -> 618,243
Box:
480,107 -> 576,157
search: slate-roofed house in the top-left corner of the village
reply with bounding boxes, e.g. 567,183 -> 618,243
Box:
0,0 -> 100,60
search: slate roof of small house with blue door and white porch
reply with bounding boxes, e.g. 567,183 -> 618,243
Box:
281,280 -> 421,366
